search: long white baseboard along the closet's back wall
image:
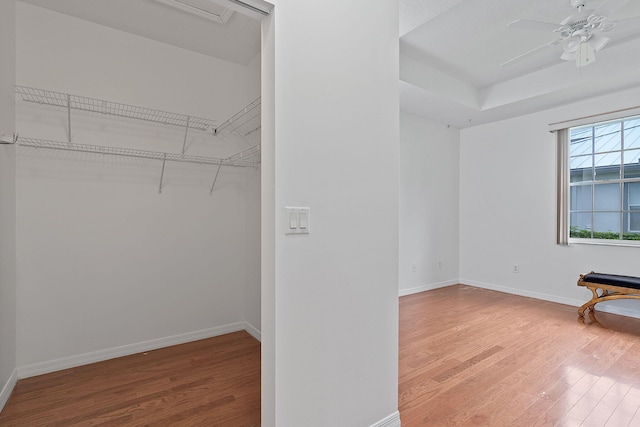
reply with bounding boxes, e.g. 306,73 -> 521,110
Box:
17,322 -> 248,379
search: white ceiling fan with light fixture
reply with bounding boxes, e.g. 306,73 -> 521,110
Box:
500,0 -> 636,68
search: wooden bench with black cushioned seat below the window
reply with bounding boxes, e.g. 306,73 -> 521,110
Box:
578,271 -> 640,317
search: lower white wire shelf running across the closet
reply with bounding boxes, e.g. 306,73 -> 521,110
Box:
17,137 -> 259,167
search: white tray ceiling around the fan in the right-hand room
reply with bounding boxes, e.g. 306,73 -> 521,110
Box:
400,0 -> 640,128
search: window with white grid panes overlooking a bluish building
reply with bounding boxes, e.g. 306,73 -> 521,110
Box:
568,116 -> 640,243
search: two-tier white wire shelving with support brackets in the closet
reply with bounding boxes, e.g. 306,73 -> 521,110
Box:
15,85 -> 261,194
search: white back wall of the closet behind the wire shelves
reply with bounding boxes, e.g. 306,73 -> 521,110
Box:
17,3 -> 259,375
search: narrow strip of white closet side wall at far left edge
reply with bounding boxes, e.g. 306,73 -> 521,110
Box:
0,0 -> 16,411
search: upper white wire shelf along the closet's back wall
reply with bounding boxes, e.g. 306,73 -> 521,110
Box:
15,85 -> 217,133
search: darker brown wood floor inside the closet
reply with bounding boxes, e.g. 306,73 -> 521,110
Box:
0,331 -> 260,427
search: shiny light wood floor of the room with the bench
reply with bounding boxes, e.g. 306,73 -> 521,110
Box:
399,285 -> 640,427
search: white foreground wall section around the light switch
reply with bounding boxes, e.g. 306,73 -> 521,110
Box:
262,0 -> 399,427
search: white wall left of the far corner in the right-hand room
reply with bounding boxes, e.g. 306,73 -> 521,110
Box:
400,112 -> 460,295
